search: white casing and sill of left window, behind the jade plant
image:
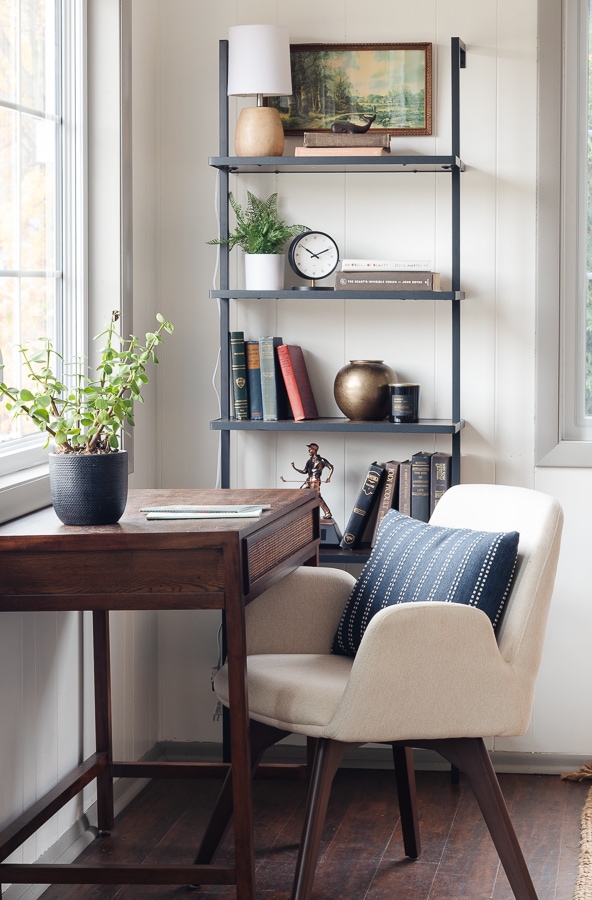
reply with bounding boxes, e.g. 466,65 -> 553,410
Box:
0,0 -> 133,522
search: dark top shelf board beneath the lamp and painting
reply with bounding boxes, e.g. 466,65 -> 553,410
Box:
208,153 -> 465,175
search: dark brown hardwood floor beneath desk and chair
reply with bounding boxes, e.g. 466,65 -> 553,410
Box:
44,769 -> 590,900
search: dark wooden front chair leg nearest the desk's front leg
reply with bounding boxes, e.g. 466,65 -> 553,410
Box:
292,738 -> 351,900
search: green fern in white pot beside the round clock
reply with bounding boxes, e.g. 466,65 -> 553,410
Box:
208,191 -> 308,291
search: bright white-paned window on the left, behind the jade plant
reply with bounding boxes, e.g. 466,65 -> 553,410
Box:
0,0 -> 84,476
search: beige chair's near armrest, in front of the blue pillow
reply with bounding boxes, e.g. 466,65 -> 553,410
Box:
328,602 -> 534,742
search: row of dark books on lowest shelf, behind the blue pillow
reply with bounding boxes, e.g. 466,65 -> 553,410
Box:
341,450 -> 452,550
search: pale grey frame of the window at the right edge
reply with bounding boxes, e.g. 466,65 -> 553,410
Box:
536,0 -> 592,468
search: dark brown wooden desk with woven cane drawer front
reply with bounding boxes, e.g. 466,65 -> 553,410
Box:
0,490 -> 319,900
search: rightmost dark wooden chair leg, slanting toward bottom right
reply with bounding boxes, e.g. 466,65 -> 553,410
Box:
425,738 -> 537,900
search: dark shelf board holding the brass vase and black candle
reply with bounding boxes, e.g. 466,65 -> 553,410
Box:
210,417 -> 465,434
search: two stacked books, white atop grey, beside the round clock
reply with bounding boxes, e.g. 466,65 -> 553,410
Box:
335,259 -> 440,291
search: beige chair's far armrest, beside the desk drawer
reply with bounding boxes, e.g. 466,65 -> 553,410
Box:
245,566 -> 355,654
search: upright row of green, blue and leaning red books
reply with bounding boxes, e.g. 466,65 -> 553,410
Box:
230,331 -> 319,422
